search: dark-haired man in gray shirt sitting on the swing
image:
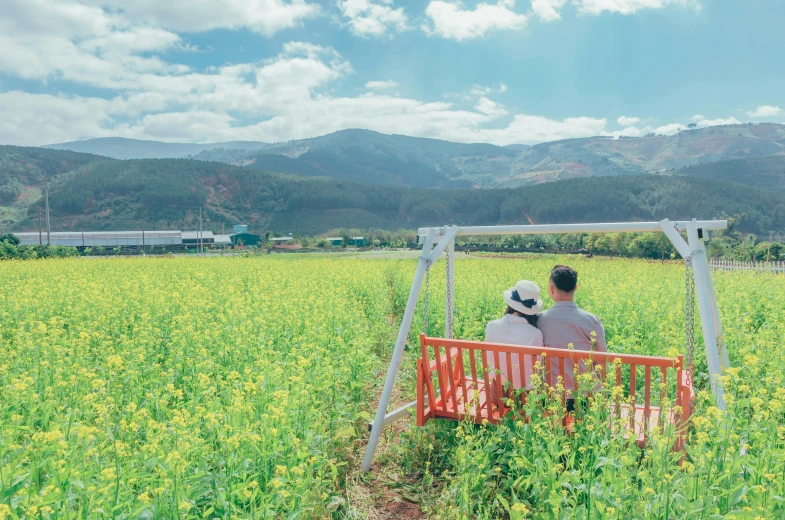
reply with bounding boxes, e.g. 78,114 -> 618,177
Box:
537,265 -> 608,412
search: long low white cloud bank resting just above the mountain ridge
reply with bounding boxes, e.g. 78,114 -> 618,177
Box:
0,38 -> 607,144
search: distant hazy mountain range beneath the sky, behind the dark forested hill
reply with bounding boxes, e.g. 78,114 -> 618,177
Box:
44,123 -> 785,188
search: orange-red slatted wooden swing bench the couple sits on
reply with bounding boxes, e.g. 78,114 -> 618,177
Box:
416,334 -> 695,450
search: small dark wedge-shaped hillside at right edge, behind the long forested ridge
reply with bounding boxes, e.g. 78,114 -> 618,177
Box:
674,155 -> 785,190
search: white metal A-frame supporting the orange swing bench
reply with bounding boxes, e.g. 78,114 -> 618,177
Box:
361,219 -> 730,472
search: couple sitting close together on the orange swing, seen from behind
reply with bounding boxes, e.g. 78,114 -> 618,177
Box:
485,265 -> 607,412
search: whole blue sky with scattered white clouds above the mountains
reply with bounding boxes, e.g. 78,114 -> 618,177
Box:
0,0 -> 785,145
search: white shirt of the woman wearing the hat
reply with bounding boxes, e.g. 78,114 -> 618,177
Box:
485,314 -> 543,388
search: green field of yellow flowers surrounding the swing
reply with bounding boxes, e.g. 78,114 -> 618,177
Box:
0,255 -> 785,520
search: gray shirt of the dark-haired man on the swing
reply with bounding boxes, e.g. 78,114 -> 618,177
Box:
537,302 -> 608,390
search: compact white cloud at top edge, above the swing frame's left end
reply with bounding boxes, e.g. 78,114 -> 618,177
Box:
424,0 -> 526,41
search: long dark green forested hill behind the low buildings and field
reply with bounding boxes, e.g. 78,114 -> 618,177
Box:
0,147 -> 785,234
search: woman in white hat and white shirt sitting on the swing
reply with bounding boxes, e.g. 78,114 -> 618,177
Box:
485,280 -> 543,403
